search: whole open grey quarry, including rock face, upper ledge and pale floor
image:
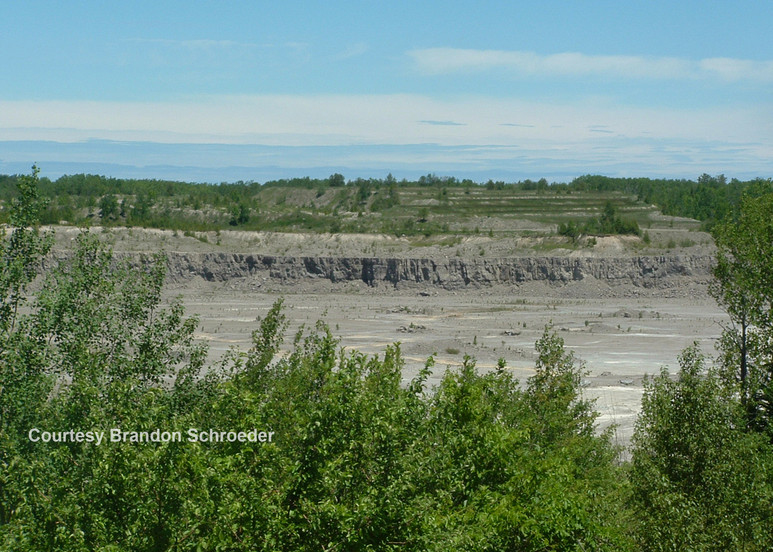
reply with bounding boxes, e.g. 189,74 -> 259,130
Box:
47,227 -> 726,446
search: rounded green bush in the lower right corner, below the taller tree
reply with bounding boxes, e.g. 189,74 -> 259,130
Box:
630,346 -> 773,551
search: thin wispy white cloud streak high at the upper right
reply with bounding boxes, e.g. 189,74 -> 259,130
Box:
408,48 -> 773,82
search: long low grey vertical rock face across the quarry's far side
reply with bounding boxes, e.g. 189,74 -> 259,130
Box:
155,252 -> 713,290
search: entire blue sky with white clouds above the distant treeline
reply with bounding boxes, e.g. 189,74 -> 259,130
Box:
0,0 -> 773,182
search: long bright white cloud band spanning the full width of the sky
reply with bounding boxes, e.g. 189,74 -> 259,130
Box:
0,94 -> 773,146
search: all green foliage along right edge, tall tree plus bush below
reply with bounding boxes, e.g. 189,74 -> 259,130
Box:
630,190 -> 773,551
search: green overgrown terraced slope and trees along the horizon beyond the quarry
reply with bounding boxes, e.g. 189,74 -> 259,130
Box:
0,168 -> 773,239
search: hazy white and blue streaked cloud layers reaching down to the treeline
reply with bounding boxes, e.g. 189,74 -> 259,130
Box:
0,94 -> 773,178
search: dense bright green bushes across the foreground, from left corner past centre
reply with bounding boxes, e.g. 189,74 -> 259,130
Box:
0,286 -> 626,550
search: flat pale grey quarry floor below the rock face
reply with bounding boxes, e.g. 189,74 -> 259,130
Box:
167,279 -> 726,446
